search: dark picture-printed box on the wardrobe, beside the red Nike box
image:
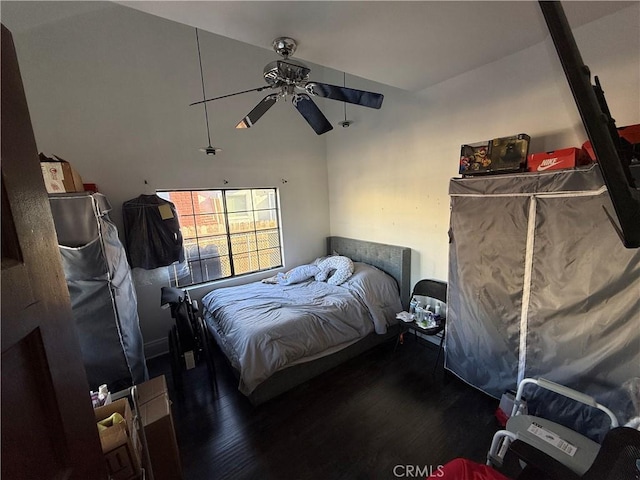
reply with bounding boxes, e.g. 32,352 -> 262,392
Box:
459,133 -> 530,176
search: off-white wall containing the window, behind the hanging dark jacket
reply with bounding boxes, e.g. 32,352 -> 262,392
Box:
12,4 -> 329,355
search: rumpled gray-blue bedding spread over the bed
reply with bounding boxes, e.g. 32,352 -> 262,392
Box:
202,262 -> 402,395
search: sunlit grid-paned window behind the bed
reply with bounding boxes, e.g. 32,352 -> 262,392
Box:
157,188 -> 282,287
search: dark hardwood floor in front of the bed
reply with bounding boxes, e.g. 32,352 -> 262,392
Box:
148,336 -> 499,480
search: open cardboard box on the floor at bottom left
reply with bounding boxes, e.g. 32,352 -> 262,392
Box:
94,398 -> 142,480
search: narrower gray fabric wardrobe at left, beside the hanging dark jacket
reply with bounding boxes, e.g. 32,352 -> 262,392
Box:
49,193 -> 148,392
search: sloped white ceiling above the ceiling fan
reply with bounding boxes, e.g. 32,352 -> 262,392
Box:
1,0 -> 634,91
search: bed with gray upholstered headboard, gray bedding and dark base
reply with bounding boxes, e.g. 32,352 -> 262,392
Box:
202,237 -> 411,405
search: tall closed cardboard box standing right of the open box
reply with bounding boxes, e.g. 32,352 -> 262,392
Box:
138,392 -> 183,480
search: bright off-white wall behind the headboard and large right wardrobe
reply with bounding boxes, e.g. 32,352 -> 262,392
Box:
327,4 -> 640,283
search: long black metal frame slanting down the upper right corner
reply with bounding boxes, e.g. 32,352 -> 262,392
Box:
538,1 -> 640,248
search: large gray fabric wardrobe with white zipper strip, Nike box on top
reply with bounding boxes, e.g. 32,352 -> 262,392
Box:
445,165 -> 640,423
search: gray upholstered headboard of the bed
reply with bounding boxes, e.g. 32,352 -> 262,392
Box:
327,237 -> 411,309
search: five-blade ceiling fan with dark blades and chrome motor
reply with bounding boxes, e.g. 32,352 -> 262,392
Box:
191,37 -> 384,135
